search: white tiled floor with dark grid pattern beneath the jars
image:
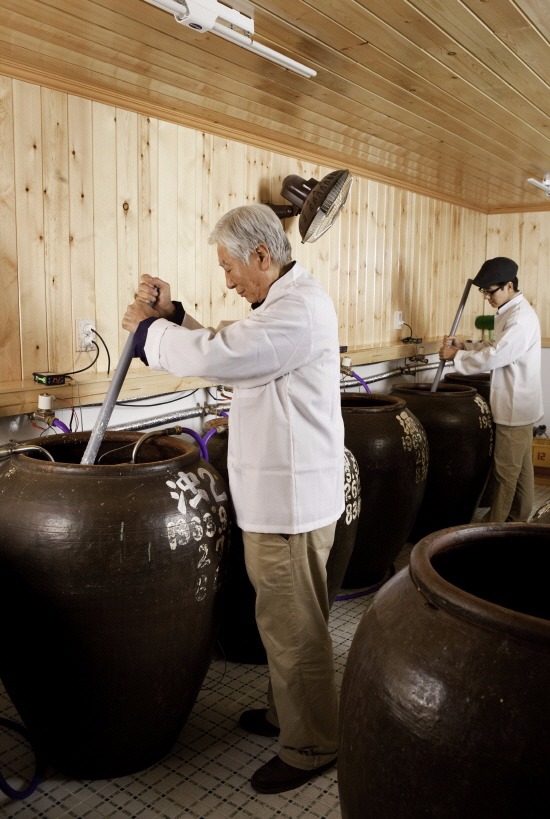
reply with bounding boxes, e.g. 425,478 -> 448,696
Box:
0,485 -> 550,819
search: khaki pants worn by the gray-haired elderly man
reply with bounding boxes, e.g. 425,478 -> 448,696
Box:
243,524 -> 338,770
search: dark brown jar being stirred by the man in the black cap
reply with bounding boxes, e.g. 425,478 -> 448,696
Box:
392,382 -> 494,542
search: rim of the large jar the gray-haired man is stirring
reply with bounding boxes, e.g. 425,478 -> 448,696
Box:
8,431 -> 200,475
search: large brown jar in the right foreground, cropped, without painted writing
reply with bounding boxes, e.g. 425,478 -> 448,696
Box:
338,523 -> 550,819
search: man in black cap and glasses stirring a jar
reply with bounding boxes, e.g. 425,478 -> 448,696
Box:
439,256 -> 544,522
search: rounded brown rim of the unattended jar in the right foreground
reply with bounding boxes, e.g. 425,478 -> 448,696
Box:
409,523 -> 550,647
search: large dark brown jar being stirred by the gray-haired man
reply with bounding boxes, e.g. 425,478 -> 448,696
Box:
0,433 -> 228,778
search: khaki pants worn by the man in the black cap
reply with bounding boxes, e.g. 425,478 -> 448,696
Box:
490,424 -> 535,523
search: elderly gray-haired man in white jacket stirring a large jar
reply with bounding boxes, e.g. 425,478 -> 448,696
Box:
123,205 -> 344,793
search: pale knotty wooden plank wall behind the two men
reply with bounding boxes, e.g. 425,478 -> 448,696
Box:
0,77 -> 550,414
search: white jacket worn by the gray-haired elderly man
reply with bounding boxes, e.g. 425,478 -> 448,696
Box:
145,264 -> 344,534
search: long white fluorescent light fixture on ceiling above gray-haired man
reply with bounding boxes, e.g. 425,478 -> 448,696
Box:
145,0 -> 317,79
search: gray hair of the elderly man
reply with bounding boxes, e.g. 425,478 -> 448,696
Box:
208,205 -> 292,267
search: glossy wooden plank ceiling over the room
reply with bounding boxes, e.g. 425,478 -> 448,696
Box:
0,0 -> 550,213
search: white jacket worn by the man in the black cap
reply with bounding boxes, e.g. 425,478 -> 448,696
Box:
454,293 -> 544,427
